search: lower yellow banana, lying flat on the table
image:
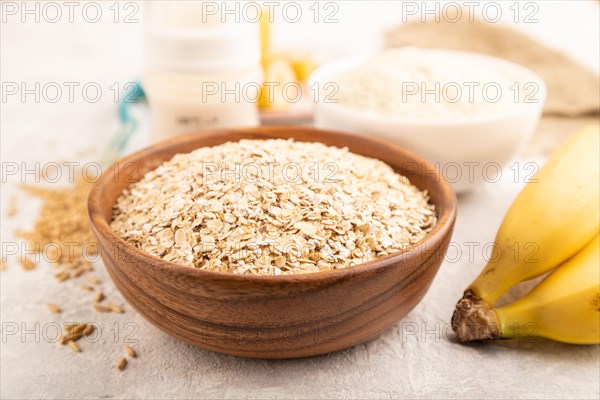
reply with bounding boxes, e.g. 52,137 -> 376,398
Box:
463,236 -> 600,344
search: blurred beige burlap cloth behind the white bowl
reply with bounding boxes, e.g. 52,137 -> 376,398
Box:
385,18 -> 600,155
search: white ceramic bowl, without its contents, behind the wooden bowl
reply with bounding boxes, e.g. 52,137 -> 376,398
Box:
309,50 -> 547,192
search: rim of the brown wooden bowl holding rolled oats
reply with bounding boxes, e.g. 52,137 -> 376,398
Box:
88,125 -> 458,283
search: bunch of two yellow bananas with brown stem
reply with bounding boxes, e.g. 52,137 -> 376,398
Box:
452,126 -> 600,344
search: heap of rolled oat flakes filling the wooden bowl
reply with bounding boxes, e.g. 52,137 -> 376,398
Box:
111,139 -> 437,275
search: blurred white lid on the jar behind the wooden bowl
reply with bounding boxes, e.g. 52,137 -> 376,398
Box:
145,2 -> 260,72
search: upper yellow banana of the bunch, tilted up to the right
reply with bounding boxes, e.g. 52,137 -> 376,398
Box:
468,126 -> 600,306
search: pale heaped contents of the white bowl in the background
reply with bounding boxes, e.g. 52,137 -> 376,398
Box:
335,47 -> 527,120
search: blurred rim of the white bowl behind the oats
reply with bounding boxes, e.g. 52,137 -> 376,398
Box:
308,46 -> 548,127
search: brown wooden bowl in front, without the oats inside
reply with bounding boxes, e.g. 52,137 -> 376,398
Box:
89,127 -> 456,358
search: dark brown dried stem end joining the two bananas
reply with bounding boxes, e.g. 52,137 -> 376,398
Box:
451,290 -> 502,342
